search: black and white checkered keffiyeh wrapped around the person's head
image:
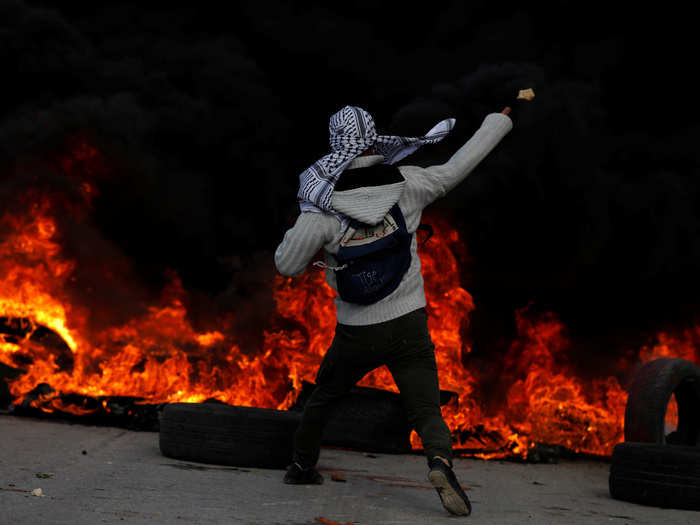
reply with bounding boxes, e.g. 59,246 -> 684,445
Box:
297,106 -> 455,218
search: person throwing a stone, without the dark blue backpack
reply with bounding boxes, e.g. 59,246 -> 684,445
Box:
275,106 -> 512,515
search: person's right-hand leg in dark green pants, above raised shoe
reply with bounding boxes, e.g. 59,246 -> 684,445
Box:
387,309 -> 452,466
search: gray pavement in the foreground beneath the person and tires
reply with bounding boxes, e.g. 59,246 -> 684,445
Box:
0,415 -> 700,525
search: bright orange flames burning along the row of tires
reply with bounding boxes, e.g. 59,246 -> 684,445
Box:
0,142 -> 700,459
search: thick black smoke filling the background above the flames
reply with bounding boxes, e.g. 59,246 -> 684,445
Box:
0,0 -> 700,354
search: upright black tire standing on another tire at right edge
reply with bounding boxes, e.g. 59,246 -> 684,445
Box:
625,357 -> 700,446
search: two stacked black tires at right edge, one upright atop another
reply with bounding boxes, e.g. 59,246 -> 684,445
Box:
609,358 -> 700,510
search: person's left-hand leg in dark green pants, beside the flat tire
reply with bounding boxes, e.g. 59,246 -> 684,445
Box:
293,324 -> 382,469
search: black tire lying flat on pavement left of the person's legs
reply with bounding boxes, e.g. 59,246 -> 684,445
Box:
159,403 -> 301,469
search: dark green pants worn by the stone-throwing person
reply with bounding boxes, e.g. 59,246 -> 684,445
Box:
293,308 -> 452,468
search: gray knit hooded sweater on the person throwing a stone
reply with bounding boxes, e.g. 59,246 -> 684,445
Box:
275,113 -> 513,325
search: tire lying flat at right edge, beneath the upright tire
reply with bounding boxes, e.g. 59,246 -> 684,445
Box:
609,443 -> 700,510
